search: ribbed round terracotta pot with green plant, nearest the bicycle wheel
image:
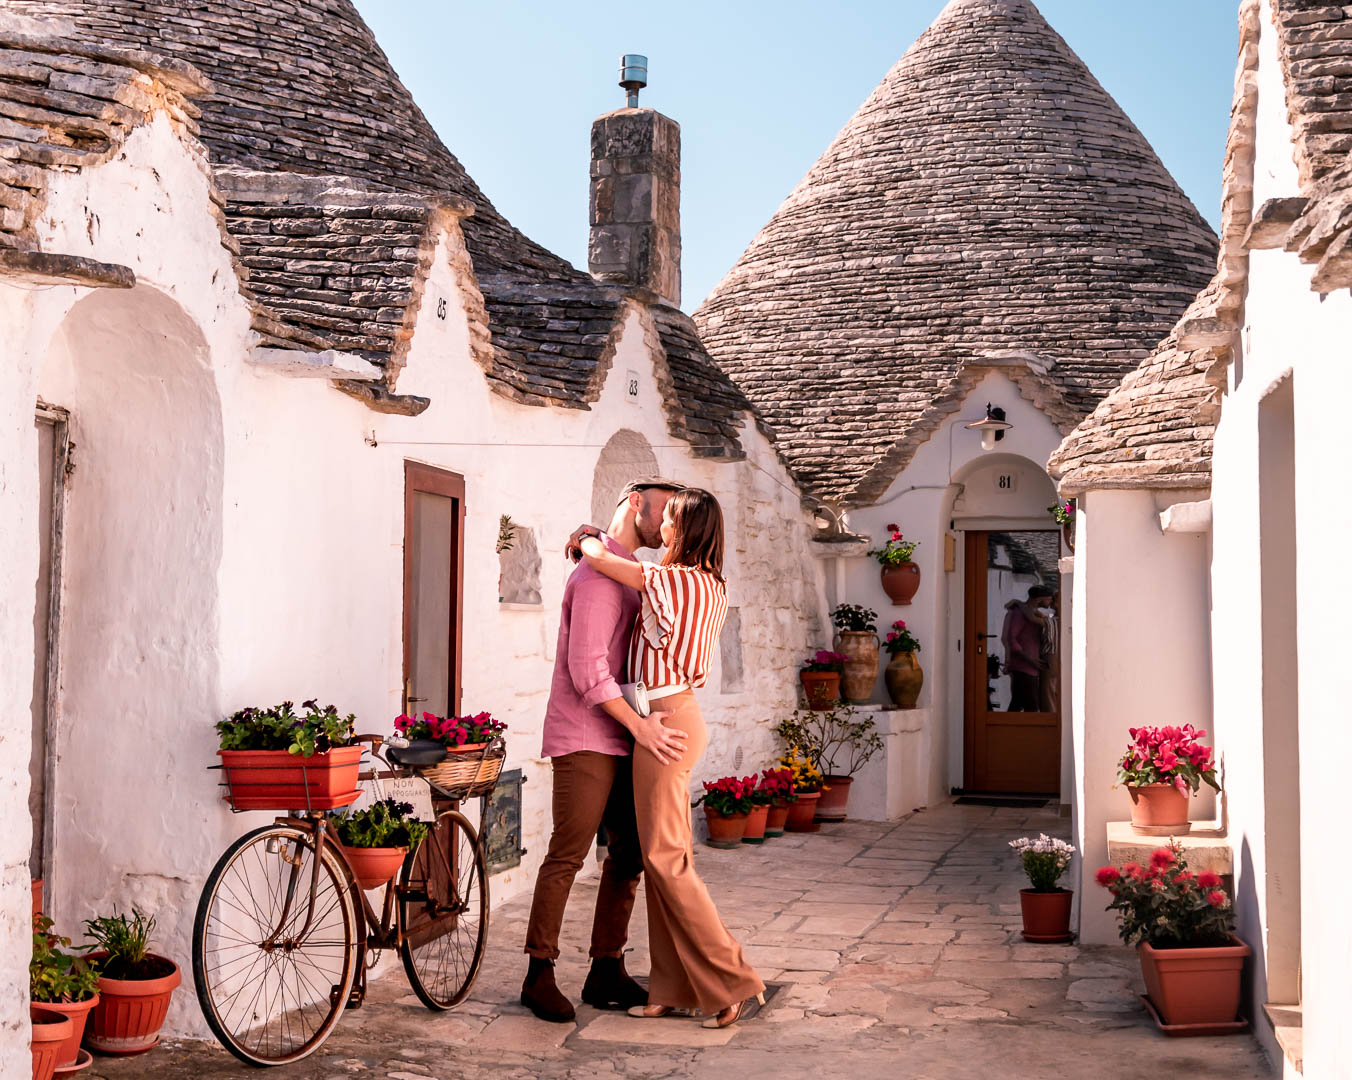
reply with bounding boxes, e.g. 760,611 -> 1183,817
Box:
85,907 -> 183,1054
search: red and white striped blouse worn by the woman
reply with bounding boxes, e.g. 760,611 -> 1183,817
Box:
629,562 -> 727,691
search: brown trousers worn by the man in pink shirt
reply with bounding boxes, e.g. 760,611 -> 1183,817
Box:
526,750 -> 644,960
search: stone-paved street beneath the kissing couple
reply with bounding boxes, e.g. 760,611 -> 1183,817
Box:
85,806 -> 1272,1080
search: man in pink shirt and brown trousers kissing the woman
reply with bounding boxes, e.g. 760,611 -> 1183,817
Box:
521,477 -> 685,1023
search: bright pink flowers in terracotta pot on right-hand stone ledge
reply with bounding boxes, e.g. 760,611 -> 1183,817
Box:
1117,723 -> 1221,837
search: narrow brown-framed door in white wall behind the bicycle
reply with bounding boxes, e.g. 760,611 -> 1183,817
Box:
404,461 -> 465,716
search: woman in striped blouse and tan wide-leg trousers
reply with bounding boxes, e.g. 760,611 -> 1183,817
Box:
581,488 -> 765,1027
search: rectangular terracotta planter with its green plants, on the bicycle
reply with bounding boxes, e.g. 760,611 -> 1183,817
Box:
216,699 -> 361,810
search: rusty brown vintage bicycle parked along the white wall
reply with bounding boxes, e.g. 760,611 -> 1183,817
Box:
192,735 -> 506,1065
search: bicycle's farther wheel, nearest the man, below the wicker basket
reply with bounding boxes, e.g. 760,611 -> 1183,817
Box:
399,810 -> 488,1010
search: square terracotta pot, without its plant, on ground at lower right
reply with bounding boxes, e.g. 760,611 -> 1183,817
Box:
1137,934 -> 1253,1025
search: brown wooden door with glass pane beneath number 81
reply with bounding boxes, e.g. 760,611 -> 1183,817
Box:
963,529 -> 1061,795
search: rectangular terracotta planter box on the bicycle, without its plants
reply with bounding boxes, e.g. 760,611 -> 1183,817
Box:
216,746 -> 361,810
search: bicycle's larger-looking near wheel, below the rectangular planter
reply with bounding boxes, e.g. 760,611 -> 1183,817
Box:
192,825 -> 357,1065
